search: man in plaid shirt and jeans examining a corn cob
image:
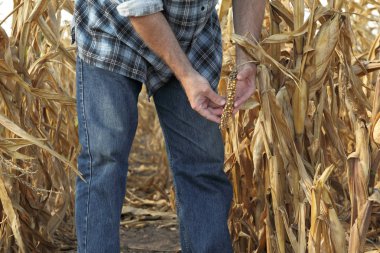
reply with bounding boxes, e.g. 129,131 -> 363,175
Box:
72,0 -> 265,253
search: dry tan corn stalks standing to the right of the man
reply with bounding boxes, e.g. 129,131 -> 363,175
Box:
220,0 -> 380,253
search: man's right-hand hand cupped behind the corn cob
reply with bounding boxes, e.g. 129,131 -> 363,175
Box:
233,63 -> 257,114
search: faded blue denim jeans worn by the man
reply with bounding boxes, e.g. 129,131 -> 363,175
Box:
75,57 -> 232,253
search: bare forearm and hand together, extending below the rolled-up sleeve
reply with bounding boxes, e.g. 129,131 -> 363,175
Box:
130,12 -> 225,123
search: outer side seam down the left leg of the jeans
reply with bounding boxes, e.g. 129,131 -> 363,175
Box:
79,58 -> 92,252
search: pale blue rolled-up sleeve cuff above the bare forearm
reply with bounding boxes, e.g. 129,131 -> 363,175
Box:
117,0 -> 164,17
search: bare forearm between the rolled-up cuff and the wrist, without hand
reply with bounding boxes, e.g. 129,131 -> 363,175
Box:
130,12 -> 195,83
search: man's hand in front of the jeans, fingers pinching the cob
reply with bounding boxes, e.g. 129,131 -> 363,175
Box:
181,73 -> 226,123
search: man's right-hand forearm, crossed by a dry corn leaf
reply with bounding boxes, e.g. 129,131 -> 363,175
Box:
233,0 -> 265,64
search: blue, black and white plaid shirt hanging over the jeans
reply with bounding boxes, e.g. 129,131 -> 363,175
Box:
71,0 -> 222,96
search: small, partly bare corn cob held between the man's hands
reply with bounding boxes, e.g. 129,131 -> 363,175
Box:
220,70 -> 237,129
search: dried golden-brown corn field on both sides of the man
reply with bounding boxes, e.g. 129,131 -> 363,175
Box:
0,0 -> 380,253
